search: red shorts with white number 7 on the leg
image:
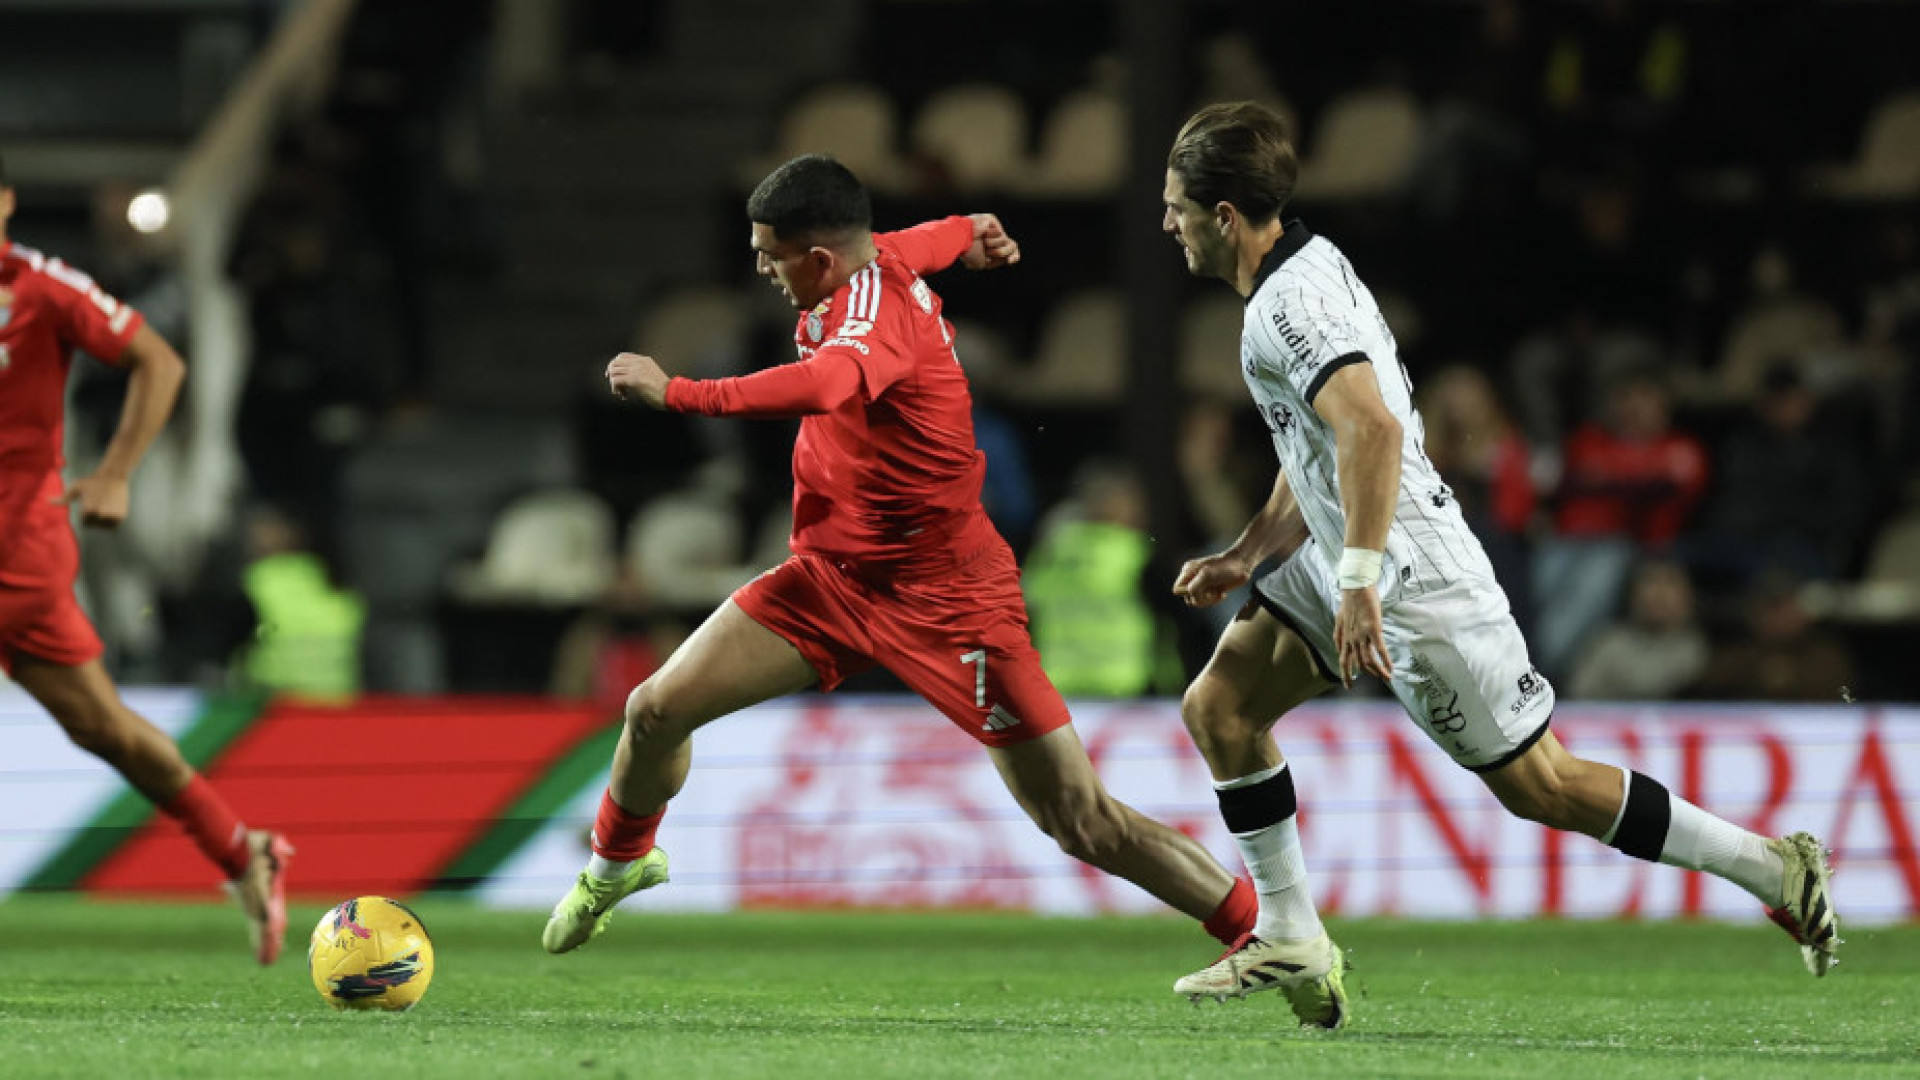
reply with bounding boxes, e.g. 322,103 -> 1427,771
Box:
733,540 -> 1073,746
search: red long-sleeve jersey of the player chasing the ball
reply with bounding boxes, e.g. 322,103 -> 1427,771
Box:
666,217 -> 998,578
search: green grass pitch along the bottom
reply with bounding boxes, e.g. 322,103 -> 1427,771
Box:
0,897 -> 1920,1080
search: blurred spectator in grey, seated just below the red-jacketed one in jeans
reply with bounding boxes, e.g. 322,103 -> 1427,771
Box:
1569,561 -> 1707,701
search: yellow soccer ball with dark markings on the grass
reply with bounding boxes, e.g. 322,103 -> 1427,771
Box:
307,896 -> 434,1011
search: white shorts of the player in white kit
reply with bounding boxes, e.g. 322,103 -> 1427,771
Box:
1254,540 -> 1553,773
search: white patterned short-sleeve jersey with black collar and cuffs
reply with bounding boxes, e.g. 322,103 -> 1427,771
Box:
1240,221 -> 1500,601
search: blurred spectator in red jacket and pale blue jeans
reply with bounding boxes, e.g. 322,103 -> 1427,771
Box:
1534,373 -> 1707,676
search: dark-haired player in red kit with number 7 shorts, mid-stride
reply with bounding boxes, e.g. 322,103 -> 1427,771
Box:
541,156 -> 1258,953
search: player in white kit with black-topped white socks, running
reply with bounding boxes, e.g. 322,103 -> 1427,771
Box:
1164,102 -> 1839,1028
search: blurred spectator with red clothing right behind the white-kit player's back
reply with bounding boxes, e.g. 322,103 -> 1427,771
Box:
1421,367 -> 1538,626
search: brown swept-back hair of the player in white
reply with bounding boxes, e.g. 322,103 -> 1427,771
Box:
1167,102 -> 1300,223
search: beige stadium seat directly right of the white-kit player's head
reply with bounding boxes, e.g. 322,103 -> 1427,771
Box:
1300,86 -> 1421,200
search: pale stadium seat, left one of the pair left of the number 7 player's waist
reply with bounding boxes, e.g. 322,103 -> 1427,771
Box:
453,490 -> 612,603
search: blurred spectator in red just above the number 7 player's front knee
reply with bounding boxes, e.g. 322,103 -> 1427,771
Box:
547,567 -> 687,715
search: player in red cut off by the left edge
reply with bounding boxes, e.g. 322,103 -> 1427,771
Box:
0,153 -> 294,965
